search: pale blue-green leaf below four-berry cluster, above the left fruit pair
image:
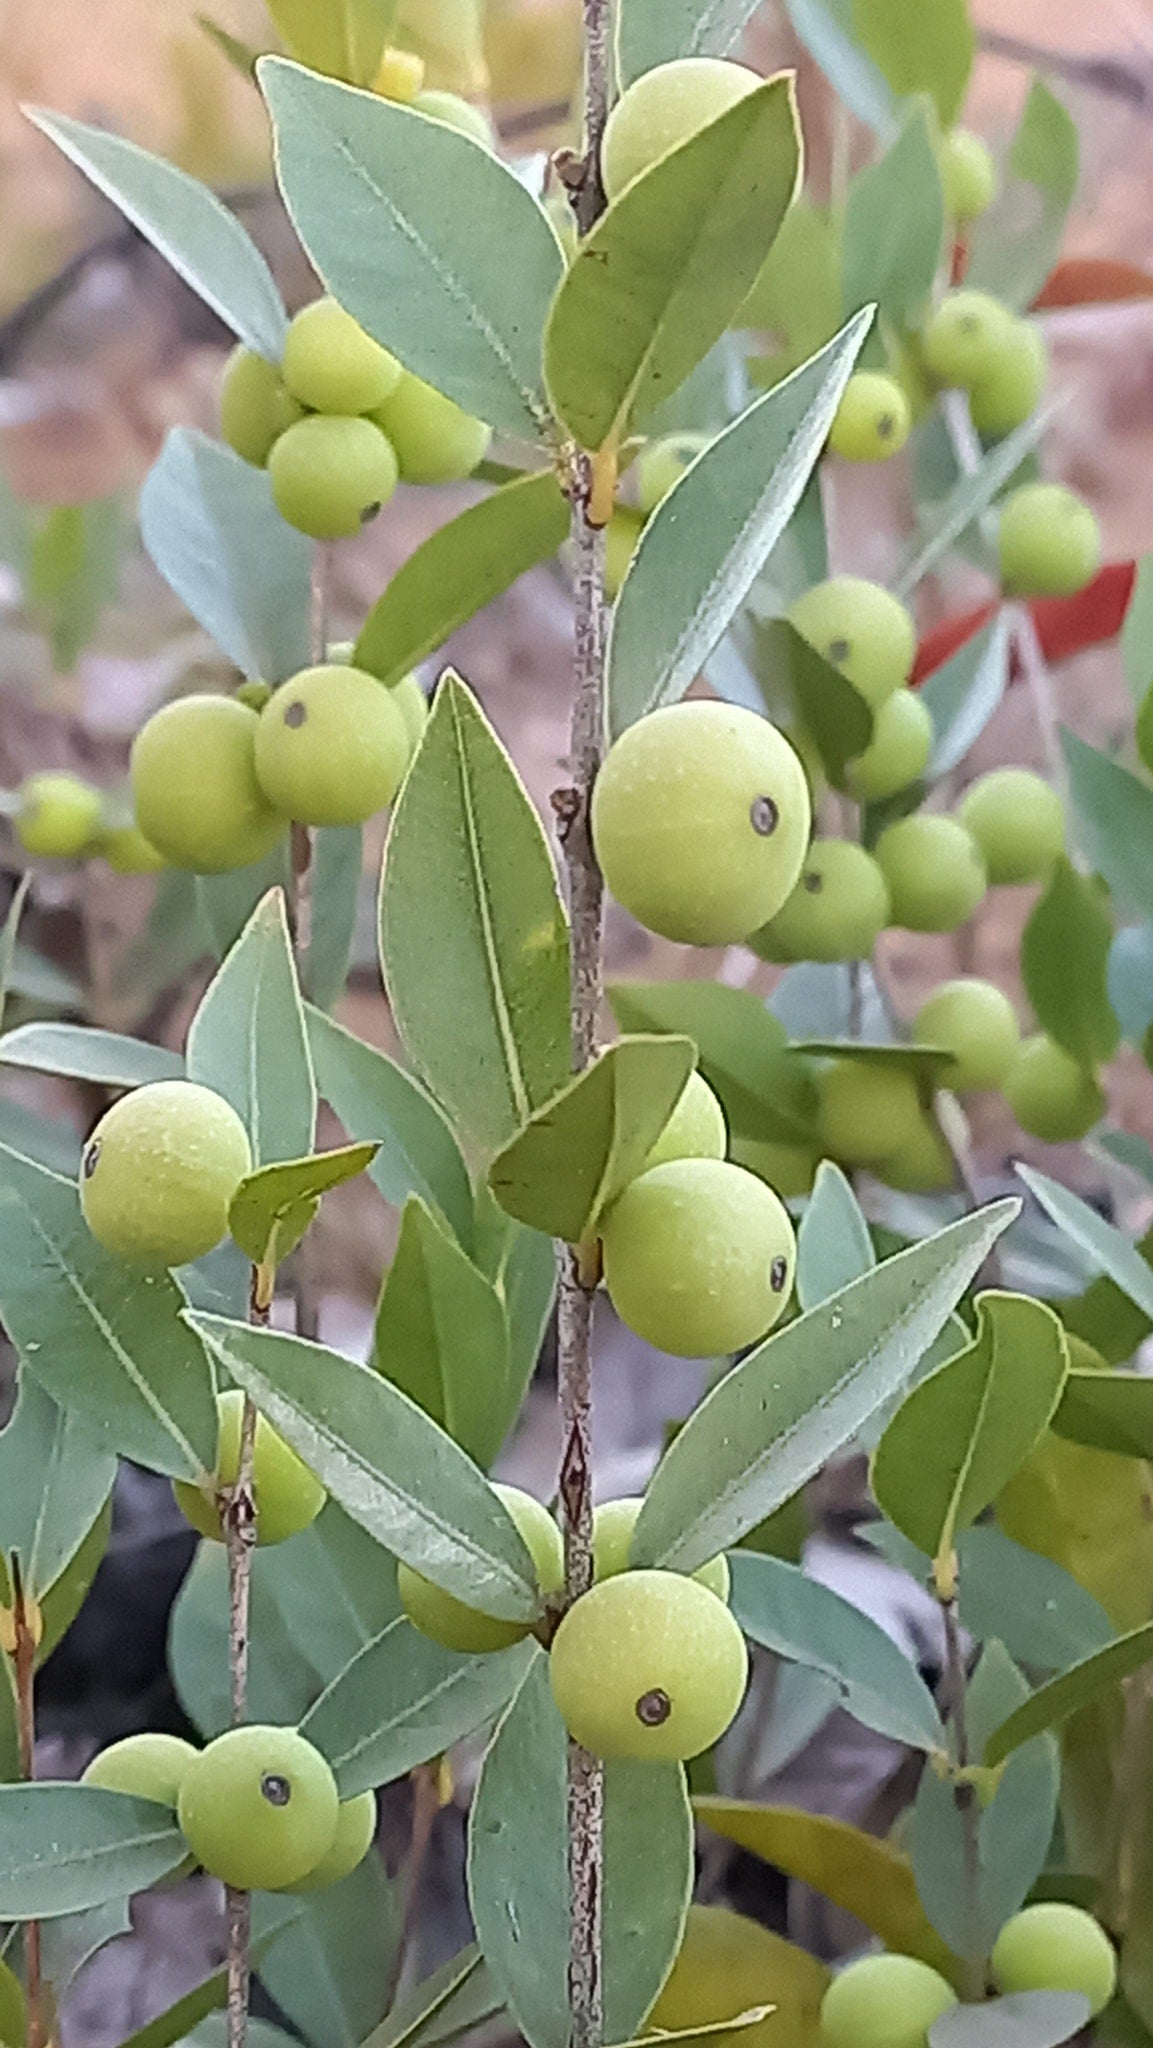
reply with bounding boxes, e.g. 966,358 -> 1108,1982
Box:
139,426 -> 311,682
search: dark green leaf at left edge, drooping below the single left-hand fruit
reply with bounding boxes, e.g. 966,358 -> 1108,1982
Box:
0,1147 -> 217,1479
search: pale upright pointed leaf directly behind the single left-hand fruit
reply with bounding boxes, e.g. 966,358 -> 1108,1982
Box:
186,889 -> 315,1165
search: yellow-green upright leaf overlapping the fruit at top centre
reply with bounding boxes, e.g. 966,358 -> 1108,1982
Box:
545,76 -> 801,449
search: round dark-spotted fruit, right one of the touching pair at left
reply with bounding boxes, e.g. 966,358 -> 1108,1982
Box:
256,664 -> 410,825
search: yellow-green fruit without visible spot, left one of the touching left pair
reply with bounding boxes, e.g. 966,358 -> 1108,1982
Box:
131,696 -> 285,874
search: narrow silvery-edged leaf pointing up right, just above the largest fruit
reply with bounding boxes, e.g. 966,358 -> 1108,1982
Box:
610,311 -> 870,733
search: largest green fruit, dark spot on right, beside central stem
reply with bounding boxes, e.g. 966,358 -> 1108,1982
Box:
592,700 -> 811,946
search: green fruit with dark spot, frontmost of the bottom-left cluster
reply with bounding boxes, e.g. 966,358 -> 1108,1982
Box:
178,1724 -> 340,1892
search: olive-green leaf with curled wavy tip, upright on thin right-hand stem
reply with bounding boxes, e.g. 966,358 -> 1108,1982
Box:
872,1276 -> 1073,1565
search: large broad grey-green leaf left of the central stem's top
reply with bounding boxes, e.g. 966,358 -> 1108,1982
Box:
256,57 -> 563,440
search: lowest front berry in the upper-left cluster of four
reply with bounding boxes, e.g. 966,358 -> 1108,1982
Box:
268,414 -> 397,541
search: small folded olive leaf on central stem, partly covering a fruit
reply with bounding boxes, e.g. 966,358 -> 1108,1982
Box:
489,1038 -> 696,1245
